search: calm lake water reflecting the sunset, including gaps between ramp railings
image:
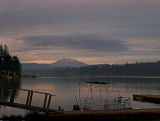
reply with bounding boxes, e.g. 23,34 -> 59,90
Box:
0,77 -> 160,115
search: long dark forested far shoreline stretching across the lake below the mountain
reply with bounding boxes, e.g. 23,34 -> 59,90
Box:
27,61 -> 160,76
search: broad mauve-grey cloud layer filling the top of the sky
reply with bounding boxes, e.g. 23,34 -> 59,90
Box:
0,0 -> 160,38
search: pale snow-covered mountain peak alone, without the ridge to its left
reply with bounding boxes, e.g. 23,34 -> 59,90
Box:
52,58 -> 87,68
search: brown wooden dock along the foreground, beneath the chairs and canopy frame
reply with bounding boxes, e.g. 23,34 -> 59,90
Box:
50,108 -> 160,117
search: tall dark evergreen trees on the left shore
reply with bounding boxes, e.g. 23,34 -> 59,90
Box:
0,44 -> 22,76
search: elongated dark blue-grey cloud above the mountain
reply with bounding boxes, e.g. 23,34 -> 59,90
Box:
21,34 -> 128,52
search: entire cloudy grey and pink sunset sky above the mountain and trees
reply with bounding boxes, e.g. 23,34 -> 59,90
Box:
0,0 -> 160,64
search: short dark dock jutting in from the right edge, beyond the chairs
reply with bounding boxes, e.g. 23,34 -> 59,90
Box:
133,94 -> 160,104
